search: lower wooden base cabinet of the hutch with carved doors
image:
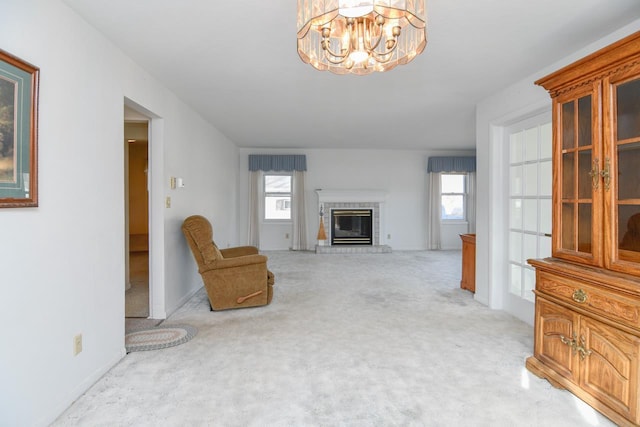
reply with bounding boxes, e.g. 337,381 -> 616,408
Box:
527,259 -> 640,426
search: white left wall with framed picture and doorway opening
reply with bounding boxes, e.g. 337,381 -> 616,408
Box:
0,0 -> 238,426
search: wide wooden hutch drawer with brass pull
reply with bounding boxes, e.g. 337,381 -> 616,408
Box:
536,272 -> 640,328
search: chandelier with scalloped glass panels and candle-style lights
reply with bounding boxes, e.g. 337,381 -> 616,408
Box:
298,0 -> 427,75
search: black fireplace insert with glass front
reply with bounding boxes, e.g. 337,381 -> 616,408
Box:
331,209 -> 373,245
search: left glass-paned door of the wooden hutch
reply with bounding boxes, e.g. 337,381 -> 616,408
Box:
554,88 -> 602,265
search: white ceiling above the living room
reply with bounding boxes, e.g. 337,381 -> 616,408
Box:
64,0 -> 640,149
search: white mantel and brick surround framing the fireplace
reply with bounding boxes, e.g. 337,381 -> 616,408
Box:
316,190 -> 391,254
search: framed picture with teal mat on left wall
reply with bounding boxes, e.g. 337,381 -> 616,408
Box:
0,50 -> 40,208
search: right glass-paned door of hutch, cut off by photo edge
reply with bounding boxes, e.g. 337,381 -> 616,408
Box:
604,77 -> 640,273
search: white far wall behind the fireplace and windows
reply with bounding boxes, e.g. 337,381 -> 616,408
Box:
239,148 -> 475,250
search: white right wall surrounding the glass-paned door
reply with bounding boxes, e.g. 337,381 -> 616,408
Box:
475,20 -> 640,323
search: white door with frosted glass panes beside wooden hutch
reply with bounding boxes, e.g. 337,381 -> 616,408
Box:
505,114 -> 552,312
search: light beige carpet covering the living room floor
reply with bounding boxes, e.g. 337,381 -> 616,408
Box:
54,252 -> 613,427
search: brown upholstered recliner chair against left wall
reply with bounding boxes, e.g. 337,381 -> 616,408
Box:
182,215 -> 274,310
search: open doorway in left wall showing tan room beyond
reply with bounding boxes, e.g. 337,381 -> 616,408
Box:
124,118 -> 150,318
